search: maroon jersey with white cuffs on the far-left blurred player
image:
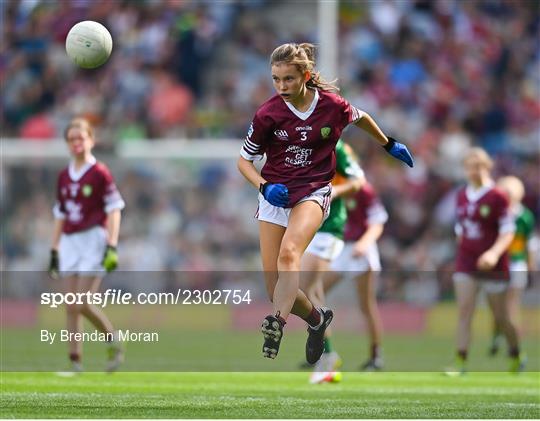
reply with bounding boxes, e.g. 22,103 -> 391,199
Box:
54,159 -> 124,234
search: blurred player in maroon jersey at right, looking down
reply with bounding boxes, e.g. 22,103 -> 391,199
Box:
448,148 -> 525,374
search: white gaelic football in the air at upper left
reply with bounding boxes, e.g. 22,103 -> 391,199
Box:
66,20 -> 112,69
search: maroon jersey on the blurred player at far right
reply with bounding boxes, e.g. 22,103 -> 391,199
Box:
456,185 -> 515,279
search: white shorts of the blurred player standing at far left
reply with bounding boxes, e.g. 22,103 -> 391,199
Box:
58,226 -> 107,276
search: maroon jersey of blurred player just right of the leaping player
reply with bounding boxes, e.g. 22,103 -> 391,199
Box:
343,182 -> 388,241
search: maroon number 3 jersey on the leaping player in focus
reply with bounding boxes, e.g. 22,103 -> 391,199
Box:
240,90 -> 363,207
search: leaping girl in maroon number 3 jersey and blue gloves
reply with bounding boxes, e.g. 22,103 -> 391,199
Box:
238,44 -> 413,363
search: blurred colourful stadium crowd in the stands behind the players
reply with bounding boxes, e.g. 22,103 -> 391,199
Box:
0,0 -> 540,303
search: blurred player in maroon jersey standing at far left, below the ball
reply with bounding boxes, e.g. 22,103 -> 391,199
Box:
49,118 -> 124,372
